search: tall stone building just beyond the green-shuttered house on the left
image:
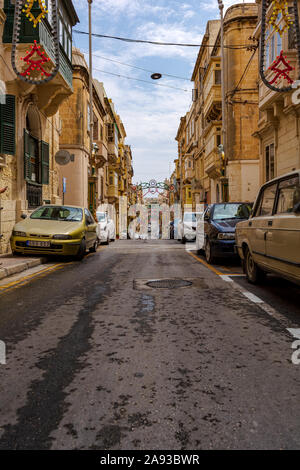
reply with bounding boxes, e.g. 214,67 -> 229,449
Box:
59,48 -> 108,213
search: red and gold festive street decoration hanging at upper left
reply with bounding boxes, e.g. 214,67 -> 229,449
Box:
11,0 -> 59,85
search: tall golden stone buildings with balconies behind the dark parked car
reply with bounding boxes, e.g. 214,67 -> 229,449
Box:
176,3 -> 259,208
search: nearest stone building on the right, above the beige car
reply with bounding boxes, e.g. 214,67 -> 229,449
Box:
254,1 -> 300,184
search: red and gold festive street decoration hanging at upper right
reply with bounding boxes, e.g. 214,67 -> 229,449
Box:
259,0 -> 300,92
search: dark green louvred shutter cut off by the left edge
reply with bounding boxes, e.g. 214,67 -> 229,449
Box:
0,95 -> 16,155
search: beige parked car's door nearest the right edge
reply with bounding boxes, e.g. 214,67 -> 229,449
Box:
266,175 -> 300,279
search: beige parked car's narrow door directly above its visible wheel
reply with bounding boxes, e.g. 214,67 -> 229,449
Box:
247,182 -> 277,264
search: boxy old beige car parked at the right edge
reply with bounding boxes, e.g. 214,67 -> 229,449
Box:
236,170 -> 300,284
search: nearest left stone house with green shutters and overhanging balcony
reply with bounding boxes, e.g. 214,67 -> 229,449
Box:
0,0 -> 79,253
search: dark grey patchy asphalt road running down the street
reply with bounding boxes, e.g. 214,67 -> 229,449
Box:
0,240 -> 300,450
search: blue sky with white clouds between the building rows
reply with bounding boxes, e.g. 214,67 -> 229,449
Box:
73,0 -> 252,182
